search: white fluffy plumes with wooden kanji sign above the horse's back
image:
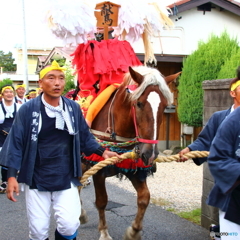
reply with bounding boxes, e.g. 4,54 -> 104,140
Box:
43,0 -> 173,64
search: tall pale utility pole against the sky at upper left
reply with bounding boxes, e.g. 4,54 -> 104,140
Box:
22,0 -> 29,91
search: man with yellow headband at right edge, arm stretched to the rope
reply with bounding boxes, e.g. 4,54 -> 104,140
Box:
179,67 -> 240,240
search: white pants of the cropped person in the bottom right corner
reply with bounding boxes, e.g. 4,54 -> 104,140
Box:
219,210 -> 240,240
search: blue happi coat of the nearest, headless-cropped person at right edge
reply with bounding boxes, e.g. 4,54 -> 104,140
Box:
207,107 -> 240,224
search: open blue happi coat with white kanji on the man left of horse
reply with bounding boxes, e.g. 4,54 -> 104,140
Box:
0,95 -> 100,186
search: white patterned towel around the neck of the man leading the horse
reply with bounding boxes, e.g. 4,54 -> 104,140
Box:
42,94 -> 74,135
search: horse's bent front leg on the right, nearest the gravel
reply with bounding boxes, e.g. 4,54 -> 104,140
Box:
124,177 -> 150,240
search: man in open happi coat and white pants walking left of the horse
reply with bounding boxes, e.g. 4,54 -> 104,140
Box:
0,61 -> 121,240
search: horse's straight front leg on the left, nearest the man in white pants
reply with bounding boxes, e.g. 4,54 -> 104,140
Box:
93,173 -> 112,240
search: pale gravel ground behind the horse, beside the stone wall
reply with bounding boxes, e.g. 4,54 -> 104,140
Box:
107,159 -> 203,212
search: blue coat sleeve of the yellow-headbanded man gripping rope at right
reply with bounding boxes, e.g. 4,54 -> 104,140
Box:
188,108 -> 231,165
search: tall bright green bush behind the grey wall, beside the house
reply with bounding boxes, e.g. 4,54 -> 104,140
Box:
178,32 -> 239,127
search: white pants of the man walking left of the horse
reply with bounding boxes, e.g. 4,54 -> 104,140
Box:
25,184 -> 81,240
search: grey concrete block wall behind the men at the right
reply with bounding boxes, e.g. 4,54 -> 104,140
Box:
201,79 -> 233,229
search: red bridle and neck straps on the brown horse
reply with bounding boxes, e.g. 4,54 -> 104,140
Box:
106,86 -> 158,144
